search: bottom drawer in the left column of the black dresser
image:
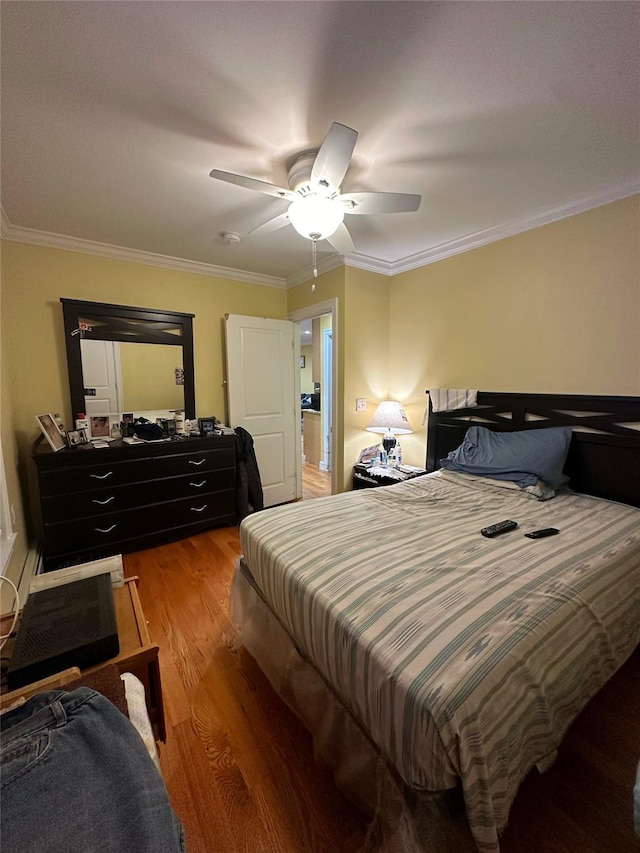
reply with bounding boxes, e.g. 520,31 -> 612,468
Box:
44,507 -> 156,557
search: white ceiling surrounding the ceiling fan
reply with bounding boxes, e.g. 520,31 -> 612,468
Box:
1,0 -> 640,284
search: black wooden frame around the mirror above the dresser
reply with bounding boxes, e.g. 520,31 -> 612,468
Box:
60,298 -> 196,420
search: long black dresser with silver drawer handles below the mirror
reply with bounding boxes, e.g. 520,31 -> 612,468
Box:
33,435 -> 236,571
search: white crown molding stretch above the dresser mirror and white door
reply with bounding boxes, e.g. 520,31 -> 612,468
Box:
0,208 -> 287,289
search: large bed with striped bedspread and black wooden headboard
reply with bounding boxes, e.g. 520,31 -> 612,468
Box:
231,393 -> 640,853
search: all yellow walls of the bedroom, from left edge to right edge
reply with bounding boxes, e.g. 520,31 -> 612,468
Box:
0,196 -> 640,576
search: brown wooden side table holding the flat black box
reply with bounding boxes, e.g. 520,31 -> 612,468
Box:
0,577 -> 166,741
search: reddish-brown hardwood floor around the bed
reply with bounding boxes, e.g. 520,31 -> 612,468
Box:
124,528 -> 640,853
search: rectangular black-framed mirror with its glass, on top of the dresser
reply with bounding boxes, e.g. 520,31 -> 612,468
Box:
60,299 -> 195,418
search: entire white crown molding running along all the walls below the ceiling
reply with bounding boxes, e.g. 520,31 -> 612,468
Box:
0,177 -> 640,282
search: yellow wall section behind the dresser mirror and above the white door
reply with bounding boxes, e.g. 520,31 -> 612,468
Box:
1,241 -> 287,568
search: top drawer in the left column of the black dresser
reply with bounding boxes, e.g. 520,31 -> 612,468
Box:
40,450 -> 155,497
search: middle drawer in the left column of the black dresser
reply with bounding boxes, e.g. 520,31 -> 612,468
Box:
42,482 -> 154,524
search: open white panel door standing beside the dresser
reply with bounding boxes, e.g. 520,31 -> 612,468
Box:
226,314 -> 302,506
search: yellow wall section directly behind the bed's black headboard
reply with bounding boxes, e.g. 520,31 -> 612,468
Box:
389,196 -> 640,464
